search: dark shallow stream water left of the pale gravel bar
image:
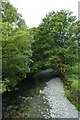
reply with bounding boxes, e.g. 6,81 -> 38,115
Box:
3,79 -> 50,120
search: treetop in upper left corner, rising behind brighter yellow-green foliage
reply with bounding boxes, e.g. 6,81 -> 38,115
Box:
1,1 -> 26,29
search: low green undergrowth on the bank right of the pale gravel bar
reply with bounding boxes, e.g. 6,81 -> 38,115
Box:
64,79 -> 80,112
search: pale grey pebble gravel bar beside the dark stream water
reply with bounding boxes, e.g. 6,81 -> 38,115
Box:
44,78 -> 78,118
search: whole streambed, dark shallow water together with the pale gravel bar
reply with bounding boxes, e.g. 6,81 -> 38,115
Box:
3,78 -> 78,120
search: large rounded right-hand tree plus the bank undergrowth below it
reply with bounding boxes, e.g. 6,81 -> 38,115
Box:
31,10 -> 80,110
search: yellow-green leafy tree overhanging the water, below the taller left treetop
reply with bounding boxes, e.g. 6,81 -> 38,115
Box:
2,23 -> 32,86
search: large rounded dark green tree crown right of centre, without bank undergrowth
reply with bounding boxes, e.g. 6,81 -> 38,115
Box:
32,10 -> 78,73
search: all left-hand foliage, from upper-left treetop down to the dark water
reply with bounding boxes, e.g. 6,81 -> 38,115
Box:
0,2 -> 32,90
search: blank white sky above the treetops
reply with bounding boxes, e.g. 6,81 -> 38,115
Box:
9,0 -> 80,28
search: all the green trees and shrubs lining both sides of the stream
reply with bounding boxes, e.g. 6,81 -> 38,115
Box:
0,2 -> 80,109
